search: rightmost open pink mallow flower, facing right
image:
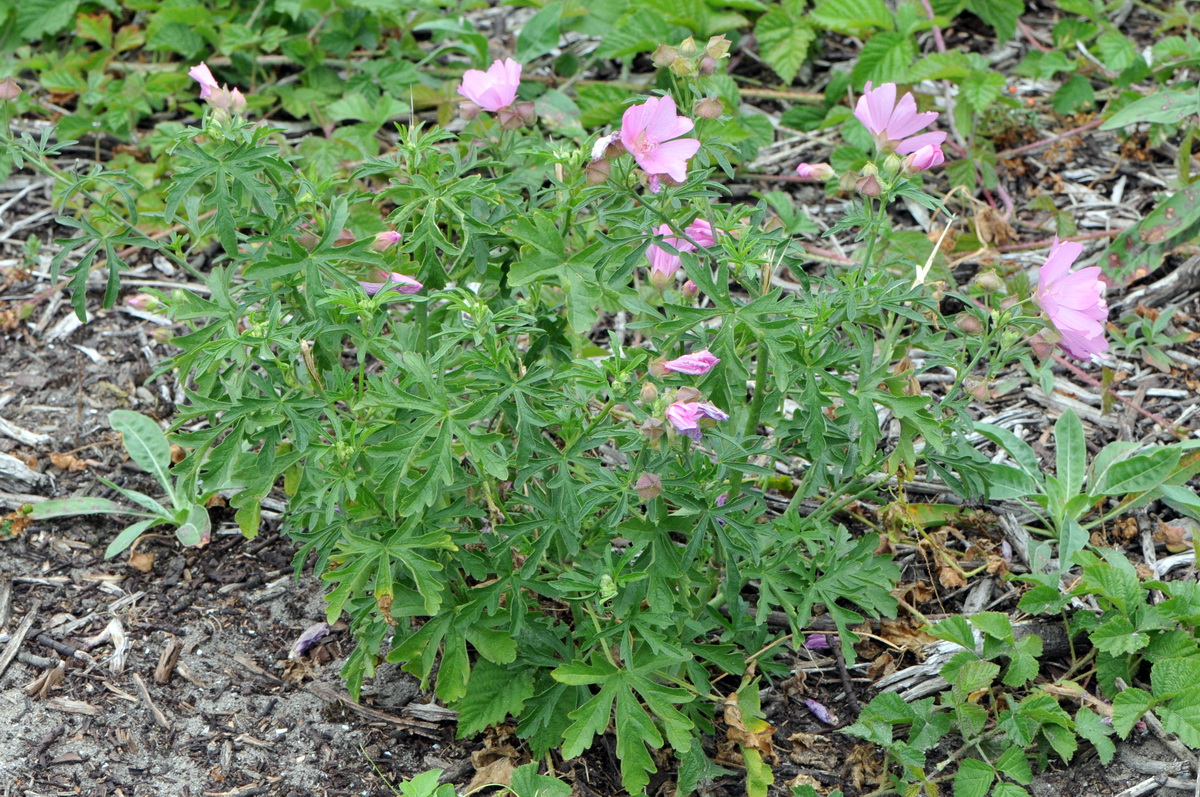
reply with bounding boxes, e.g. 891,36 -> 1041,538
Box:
1033,239 -> 1109,360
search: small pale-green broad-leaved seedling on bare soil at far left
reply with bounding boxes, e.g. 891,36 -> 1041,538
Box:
28,409 -> 212,558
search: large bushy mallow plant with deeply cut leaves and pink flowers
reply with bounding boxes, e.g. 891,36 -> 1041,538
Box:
39,51 -> 1123,795
